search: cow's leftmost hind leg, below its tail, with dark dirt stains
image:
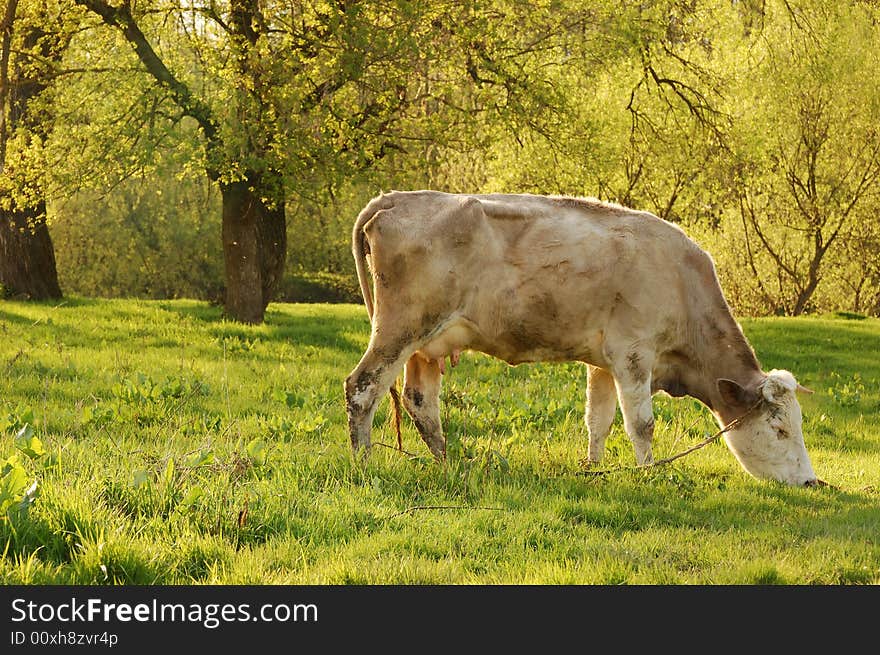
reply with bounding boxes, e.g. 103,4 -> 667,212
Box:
345,339 -> 413,456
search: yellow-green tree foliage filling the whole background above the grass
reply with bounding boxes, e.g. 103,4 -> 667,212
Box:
6,0 -> 880,315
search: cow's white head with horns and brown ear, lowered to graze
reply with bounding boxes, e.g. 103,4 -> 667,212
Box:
717,369 -> 823,486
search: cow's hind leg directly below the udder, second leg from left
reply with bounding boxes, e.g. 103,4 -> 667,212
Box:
403,353 -> 446,461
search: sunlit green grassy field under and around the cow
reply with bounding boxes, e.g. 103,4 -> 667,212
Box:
0,298 -> 880,584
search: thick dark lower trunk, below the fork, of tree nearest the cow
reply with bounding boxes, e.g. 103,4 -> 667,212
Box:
220,175 -> 287,323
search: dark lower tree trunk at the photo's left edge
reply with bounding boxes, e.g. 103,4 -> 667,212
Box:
0,203 -> 61,300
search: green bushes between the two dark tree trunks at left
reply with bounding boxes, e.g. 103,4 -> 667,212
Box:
52,169 -> 223,300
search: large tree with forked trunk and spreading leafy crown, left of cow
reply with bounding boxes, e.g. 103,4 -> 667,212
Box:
65,0 -> 588,322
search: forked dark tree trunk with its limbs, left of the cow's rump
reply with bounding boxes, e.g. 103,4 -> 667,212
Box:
76,0 -> 286,323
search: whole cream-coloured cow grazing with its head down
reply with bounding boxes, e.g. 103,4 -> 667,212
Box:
345,190 -> 824,486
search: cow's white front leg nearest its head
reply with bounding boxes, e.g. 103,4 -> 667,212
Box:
614,350 -> 654,466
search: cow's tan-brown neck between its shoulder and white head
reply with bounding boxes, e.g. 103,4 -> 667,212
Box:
689,314 -> 764,424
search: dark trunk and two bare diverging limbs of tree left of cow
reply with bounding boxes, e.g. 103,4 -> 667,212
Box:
75,0 -> 287,323
